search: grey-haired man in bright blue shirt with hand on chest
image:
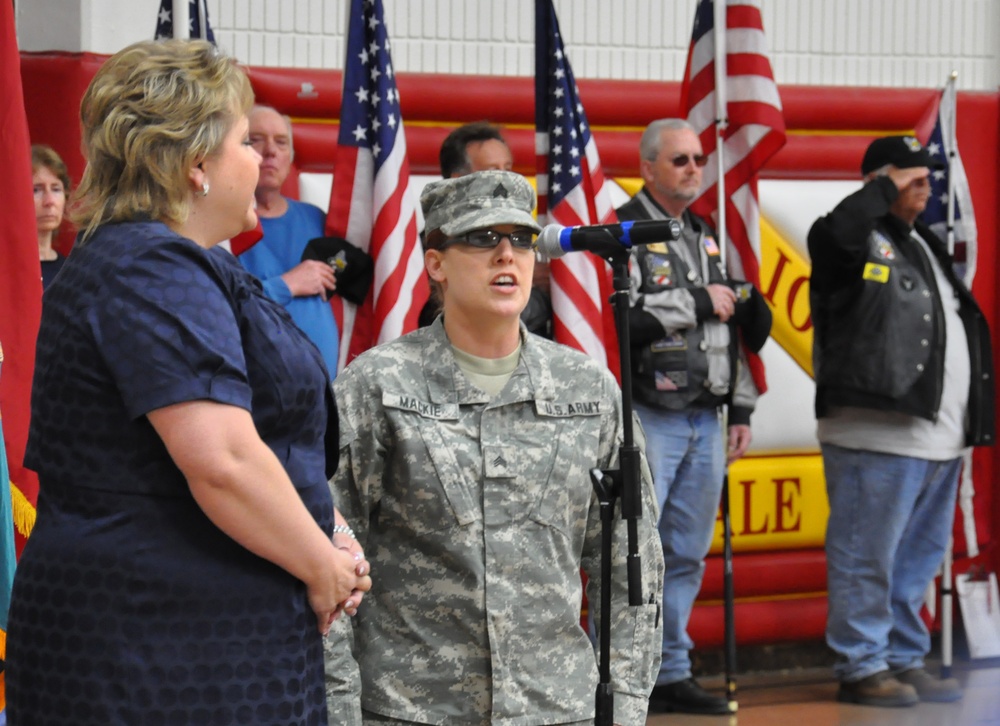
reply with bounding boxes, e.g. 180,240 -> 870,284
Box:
239,106 -> 340,380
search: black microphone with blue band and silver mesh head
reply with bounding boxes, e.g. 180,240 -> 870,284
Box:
536,219 -> 681,259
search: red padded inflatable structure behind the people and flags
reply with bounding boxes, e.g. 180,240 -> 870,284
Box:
22,53 -> 1000,647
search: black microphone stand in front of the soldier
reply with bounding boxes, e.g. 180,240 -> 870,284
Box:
590,246 -> 644,726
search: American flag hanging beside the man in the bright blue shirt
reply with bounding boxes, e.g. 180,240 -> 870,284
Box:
326,0 -> 429,367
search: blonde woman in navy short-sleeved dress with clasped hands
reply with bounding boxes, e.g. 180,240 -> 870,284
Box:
7,41 -> 371,726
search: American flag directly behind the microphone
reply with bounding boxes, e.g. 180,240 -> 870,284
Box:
535,0 -> 620,377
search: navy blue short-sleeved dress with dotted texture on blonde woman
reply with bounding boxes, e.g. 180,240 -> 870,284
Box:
7,222 -> 336,726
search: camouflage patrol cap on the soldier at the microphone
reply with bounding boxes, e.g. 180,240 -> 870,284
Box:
420,169 -> 542,237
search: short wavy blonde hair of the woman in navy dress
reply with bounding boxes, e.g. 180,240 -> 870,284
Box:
72,40 -> 253,244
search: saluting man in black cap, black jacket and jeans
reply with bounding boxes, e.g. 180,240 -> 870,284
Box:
808,136 -> 994,706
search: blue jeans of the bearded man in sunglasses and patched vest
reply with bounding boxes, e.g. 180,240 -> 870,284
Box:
635,404 -> 725,685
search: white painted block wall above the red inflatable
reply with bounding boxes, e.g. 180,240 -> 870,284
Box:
15,0 -> 1000,91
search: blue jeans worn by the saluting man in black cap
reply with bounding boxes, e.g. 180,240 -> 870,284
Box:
822,444 -> 961,682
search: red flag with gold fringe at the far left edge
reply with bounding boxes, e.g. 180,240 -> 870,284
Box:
0,2 -> 42,551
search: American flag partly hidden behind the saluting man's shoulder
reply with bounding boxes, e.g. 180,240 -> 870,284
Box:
920,77 -> 979,287
